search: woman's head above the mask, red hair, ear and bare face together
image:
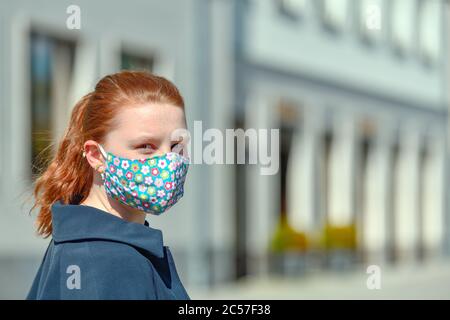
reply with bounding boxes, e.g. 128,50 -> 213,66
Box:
33,71 -> 186,236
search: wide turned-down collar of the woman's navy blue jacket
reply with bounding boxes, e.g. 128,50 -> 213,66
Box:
51,200 -> 164,258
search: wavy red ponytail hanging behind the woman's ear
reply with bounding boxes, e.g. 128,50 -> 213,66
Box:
30,92 -> 93,238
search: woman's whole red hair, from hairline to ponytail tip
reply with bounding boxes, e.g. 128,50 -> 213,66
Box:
30,71 -> 184,238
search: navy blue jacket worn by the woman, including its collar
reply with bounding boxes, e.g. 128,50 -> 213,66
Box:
27,201 -> 190,300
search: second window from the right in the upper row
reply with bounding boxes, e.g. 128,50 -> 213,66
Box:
390,0 -> 416,53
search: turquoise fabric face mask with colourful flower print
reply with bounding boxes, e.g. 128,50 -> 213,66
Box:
99,145 -> 189,215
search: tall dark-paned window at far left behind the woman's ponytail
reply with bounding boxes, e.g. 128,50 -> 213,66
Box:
30,32 -> 75,175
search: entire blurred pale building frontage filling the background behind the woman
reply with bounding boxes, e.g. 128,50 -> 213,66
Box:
0,0 -> 450,298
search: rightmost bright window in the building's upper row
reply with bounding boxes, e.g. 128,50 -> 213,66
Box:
418,0 -> 442,63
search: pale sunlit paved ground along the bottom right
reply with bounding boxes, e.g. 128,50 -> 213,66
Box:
190,261 -> 450,299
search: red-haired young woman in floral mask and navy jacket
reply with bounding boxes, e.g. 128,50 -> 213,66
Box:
27,71 -> 190,300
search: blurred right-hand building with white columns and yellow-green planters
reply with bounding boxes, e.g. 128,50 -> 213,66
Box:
230,0 -> 450,274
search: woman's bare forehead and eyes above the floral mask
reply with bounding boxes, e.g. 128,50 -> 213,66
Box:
102,103 -> 186,159
